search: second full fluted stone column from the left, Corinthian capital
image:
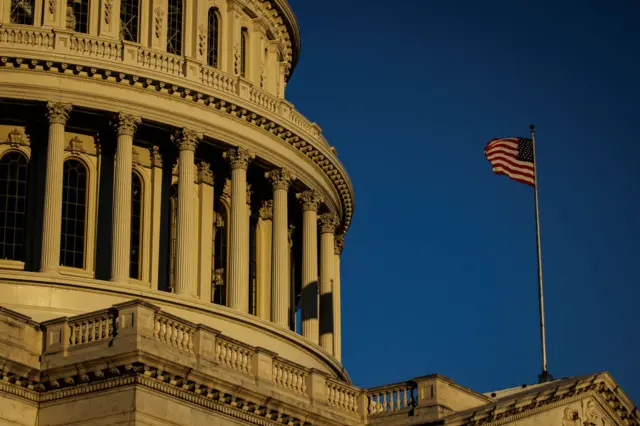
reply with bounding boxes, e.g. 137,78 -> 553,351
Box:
111,113 -> 140,283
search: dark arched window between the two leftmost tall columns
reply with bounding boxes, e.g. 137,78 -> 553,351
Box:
60,159 -> 87,268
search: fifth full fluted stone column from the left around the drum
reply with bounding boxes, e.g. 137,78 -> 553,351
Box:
264,169 -> 294,328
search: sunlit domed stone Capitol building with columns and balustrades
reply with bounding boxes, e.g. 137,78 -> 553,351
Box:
0,0 -> 640,426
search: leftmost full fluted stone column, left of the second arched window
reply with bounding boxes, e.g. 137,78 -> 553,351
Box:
40,102 -> 71,273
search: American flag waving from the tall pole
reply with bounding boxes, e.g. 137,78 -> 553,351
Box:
484,138 -> 535,186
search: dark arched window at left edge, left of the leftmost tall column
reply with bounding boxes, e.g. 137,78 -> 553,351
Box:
0,151 -> 29,261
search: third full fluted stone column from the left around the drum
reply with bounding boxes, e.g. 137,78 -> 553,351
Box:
172,129 -> 202,298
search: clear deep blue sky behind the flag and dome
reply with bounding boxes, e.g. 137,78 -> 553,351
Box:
287,0 -> 640,404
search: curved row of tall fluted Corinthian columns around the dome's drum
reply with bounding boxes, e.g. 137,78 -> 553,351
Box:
35,102 -> 343,359
